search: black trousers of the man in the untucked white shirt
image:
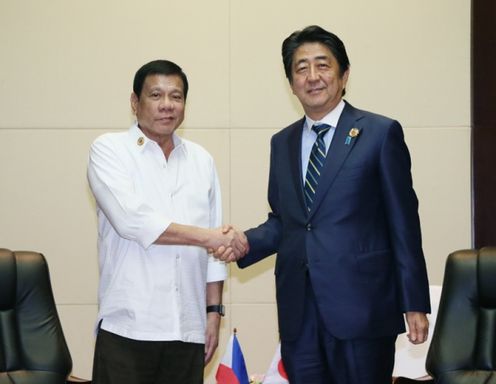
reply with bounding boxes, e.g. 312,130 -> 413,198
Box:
93,329 -> 205,384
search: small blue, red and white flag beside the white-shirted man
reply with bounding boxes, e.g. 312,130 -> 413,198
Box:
215,330 -> 249,384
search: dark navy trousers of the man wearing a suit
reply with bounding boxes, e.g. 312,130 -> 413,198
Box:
281,283 -> 396,384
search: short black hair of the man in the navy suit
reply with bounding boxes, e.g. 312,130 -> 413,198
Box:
282,25 -> 350,83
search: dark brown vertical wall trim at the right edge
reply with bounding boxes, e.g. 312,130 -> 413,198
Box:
471,0 -> 496,248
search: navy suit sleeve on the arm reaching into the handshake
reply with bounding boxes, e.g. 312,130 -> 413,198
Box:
237,138 -> 282,268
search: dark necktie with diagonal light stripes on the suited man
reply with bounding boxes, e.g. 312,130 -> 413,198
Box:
305,124 -> 331,211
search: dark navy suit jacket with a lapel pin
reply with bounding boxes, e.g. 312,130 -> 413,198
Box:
238,103 -> 430,341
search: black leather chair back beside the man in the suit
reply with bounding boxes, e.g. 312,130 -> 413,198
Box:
426,247 -> 496,384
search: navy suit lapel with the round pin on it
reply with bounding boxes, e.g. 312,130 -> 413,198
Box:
309,103 -> 362,217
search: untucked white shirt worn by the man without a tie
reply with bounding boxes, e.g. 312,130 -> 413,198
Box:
88,125 -> 227,343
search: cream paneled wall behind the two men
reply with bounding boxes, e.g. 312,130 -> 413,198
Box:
0,0 -> 471,383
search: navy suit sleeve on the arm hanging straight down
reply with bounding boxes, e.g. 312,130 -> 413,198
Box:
380,121 -> 430,313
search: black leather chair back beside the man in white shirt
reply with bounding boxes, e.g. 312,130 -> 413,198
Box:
0,249 -> 72,384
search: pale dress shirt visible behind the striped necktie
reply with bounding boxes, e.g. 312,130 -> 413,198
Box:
301,99 -> 345,178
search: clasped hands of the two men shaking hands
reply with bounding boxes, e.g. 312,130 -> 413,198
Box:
207,225 -> 250,263
